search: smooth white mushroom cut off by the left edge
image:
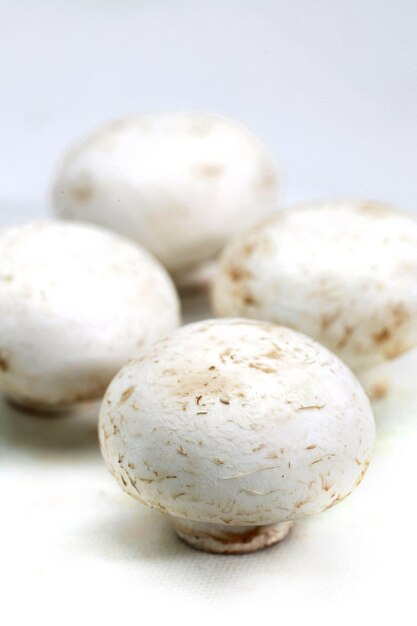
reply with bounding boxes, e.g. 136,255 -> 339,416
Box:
0,221 -> 179,410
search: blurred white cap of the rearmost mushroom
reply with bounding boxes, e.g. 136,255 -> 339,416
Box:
53,113 -> 278,273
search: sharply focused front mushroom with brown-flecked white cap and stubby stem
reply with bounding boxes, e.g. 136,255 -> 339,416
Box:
99,319 -> 374,554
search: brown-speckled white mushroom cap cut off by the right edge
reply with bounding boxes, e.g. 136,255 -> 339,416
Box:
213,201 -> 417,371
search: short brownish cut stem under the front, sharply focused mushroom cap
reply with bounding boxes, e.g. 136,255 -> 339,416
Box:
172,518 -> 294,554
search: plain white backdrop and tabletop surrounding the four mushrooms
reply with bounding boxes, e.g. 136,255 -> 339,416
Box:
0,0 -> 417,626
